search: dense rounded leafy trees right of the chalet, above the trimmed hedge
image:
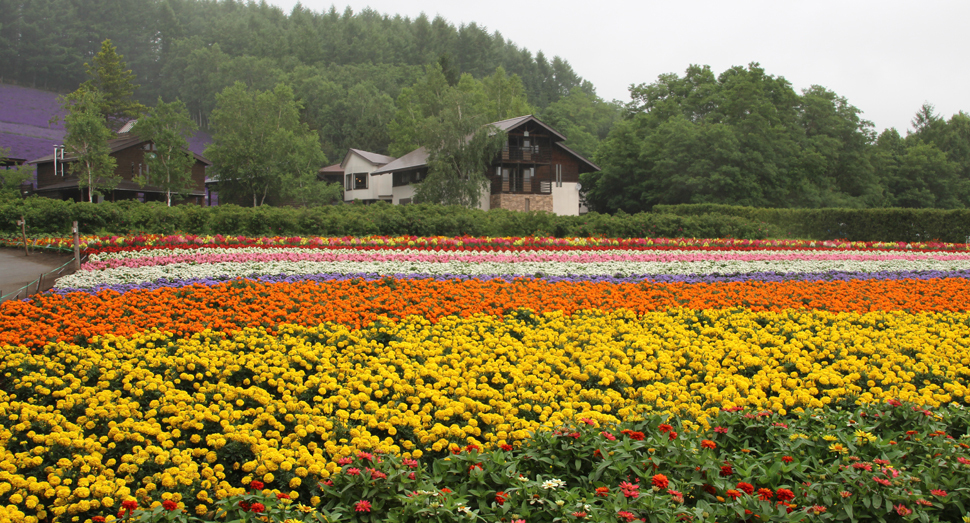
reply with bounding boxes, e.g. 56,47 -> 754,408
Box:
582,63 -> 970,213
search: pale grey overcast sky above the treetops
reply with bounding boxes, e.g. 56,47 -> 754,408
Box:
267,0 -> 970,135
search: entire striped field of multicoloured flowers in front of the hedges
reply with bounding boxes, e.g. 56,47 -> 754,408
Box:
0,236 -> 970,521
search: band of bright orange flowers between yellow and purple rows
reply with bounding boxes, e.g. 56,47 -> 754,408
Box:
0,278 -> 970,347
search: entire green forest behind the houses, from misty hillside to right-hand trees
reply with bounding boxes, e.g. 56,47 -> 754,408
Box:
0,0 -> 970,213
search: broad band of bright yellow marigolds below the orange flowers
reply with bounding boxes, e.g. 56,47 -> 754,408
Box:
0,309 -> 970,522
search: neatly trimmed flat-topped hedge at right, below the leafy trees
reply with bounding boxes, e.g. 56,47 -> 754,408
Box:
653,204 -> 970,243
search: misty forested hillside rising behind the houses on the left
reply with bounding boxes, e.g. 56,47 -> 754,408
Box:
0,0 -> 594,159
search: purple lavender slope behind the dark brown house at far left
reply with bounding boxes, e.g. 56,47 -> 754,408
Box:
0,84 -> 212,166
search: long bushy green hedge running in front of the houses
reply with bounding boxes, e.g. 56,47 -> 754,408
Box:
0,197 -> 777,239
